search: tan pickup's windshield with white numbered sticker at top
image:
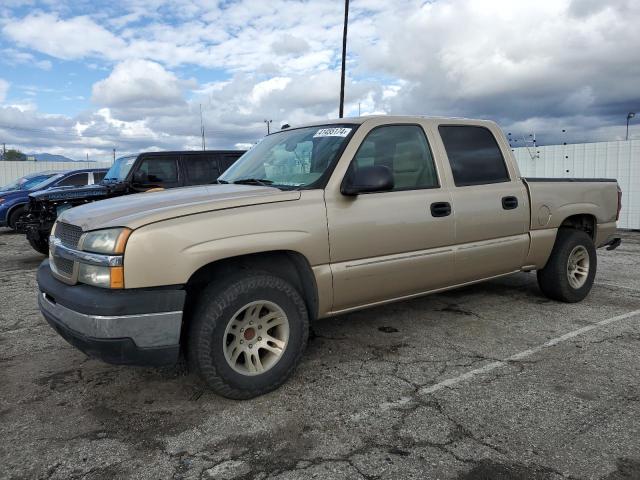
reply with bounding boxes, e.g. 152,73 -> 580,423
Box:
218,124 -> 356,189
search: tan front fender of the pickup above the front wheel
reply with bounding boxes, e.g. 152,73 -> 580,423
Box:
124,190 -> 329,288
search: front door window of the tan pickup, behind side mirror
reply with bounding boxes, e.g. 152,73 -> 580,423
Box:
352,125 -> 438,190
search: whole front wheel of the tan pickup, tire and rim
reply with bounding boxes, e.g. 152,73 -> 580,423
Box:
187,272 -> 309,399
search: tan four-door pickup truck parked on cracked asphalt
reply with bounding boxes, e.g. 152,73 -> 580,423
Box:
38,116 -> 620,398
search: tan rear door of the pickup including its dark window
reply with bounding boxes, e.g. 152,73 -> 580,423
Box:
438,124 -> 529,283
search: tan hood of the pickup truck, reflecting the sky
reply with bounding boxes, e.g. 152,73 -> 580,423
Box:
59,184 -> 300,231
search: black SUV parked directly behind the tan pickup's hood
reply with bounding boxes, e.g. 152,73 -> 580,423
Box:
17,150 -> 244,255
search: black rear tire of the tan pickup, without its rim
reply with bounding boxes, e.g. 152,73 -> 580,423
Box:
537,228 -> 598,303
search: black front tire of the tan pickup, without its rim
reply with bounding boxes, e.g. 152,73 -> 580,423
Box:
187,272 -> 309,399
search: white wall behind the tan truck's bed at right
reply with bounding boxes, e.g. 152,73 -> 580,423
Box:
513,140 -> 640,229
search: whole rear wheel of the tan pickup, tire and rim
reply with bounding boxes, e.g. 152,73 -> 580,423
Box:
537,228 -> 598,303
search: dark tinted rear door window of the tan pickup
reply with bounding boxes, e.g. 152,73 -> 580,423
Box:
438,125 -> 509,187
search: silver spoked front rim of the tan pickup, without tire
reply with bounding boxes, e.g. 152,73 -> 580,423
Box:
222,300 -> 289,376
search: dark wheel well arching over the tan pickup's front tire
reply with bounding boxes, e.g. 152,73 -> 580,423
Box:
185,250 -> 318,321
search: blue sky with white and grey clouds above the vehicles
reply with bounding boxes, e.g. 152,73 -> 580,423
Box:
0,0 -> 640,159
